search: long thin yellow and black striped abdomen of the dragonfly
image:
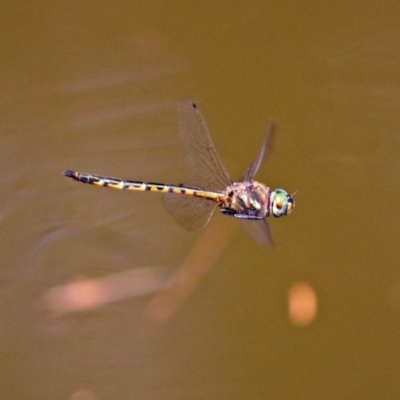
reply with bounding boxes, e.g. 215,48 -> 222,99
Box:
63,170 -> 221,203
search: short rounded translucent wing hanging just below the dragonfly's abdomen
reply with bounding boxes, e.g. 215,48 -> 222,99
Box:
162,193 -> 216,231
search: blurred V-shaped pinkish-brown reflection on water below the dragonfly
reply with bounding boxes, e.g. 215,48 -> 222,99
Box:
42,214 -> 235,322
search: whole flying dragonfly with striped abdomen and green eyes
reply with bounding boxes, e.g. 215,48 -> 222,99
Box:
63,100 -> 295,245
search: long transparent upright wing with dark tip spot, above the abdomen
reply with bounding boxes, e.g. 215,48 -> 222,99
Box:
178,100 -> 232,190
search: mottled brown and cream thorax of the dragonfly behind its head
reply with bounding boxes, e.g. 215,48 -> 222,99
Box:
220,181 -> 271,219
